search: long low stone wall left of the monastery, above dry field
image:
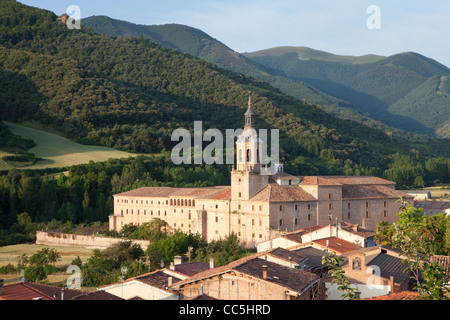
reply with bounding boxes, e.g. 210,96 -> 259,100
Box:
36,231 -> 150,250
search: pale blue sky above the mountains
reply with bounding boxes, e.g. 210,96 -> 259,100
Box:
19,0 -> 450,67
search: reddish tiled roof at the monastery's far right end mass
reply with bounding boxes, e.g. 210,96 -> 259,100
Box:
342,185 -> 414,199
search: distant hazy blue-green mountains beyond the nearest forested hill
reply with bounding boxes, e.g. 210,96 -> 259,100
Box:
82,16 -> 450,140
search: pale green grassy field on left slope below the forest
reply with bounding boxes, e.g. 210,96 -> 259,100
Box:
0,121 -> 136,170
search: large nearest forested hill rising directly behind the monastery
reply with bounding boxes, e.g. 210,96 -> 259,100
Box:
0,0 -> 445,188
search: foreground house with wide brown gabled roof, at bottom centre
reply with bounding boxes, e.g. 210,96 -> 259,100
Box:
171,249 -> 324,300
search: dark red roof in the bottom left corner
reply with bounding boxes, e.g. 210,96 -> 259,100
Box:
0,282 -> 84,300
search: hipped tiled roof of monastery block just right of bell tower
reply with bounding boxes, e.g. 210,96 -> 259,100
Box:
250,183 -> 317,202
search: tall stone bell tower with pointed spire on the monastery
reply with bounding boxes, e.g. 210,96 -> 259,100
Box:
231,95 -> 269,200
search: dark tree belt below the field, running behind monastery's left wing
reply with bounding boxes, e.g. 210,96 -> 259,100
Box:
0,156 -> 230,245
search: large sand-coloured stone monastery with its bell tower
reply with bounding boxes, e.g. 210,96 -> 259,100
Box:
109,102 -> 414,247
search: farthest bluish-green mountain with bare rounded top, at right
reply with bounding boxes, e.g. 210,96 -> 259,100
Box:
246,47 -> 450,137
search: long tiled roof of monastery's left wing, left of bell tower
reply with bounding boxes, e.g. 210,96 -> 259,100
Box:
115,186 -> 231,200
